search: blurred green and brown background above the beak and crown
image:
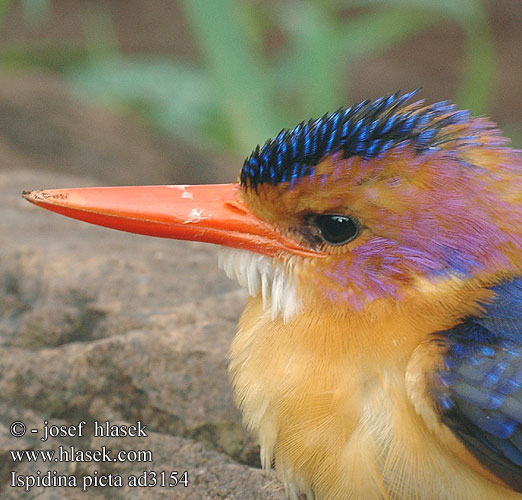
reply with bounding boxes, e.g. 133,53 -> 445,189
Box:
0,0 -> 522,184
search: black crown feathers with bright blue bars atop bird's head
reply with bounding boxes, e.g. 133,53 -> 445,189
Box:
240,89 -> 470,188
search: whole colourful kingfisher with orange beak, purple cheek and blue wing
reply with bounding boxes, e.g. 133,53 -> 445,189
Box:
23,90 -> 522,500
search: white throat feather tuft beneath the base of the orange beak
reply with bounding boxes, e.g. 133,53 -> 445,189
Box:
218,248 -> 303,323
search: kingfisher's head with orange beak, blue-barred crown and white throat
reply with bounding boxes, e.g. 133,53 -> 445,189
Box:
24,93 -> 522,320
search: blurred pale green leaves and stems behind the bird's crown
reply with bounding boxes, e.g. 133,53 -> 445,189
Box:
0,0 -> 495,155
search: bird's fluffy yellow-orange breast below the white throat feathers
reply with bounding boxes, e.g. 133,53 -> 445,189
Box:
230,298 -> 522,500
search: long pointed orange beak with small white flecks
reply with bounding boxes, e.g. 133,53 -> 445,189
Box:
22,184 -> 325,257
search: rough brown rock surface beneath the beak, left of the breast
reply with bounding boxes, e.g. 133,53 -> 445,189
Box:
0,169 -> 284,500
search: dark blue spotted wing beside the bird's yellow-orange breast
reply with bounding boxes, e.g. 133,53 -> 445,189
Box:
433,278 -> 522,492
